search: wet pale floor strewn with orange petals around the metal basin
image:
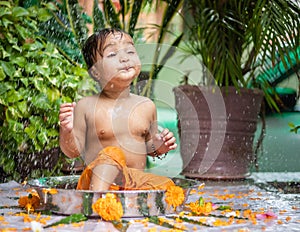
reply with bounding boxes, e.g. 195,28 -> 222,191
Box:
0,172 -> 300,232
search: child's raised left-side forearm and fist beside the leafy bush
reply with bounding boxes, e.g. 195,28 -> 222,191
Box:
59,102 -> 82,158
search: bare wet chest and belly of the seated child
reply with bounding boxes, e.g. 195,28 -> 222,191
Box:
85,96 -> 153,169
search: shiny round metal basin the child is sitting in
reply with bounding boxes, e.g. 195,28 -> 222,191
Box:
28,175 -> 200,217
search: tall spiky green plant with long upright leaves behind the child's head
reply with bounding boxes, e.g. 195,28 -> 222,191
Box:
32,0 -> 183,96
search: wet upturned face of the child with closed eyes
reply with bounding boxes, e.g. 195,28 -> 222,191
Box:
96,33 -> 141,88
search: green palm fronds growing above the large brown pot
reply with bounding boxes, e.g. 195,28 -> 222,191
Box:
186,0 -> 300,109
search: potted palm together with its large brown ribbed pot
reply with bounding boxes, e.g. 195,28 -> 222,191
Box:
174,0 -> 300,179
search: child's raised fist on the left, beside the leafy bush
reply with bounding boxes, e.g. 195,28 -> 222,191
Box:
59,102 -> 76,132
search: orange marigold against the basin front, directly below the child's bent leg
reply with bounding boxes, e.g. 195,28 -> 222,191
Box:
92,193 -> 123,221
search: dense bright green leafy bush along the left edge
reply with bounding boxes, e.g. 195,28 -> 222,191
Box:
0,1 -> 91,181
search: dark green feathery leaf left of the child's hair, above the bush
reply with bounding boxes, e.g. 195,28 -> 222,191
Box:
31,0 -> 91,65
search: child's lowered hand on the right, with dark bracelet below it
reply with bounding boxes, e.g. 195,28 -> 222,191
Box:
153,128 -> 177,154
